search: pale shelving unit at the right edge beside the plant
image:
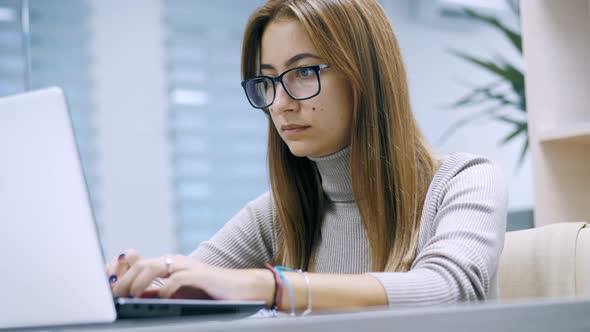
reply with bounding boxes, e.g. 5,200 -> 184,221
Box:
521,0 -> 590,226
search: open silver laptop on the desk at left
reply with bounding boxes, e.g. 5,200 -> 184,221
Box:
0,87 -> 264,329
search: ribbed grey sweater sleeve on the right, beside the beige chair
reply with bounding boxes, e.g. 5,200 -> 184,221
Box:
370,153 -> 508,307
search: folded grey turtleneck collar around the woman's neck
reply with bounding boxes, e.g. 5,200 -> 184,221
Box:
309,146 -> 354,202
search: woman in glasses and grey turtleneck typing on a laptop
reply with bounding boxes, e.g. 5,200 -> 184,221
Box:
108,0 -> 507,311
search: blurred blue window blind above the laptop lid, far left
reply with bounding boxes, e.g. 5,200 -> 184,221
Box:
0,0 -> 100,228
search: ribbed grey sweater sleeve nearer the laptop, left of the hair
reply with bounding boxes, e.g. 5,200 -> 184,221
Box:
191,192 -> 276,269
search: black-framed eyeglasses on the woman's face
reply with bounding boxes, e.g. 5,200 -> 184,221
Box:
242,64 -> 330,108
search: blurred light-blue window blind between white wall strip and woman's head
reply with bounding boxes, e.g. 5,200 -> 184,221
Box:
163,0 -> 269,253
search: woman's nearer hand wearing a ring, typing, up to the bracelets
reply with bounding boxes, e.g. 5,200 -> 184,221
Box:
113,255 -> 274,304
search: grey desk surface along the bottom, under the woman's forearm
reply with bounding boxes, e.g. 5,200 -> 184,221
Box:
10,299 -> 590,332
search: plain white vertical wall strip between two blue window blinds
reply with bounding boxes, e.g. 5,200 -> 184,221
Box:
90,0 -> 175,257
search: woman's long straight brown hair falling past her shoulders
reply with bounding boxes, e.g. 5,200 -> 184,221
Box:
242,0 -> 436,271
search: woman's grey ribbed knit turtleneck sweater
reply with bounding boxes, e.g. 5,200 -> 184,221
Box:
191,148 -> 508,307
